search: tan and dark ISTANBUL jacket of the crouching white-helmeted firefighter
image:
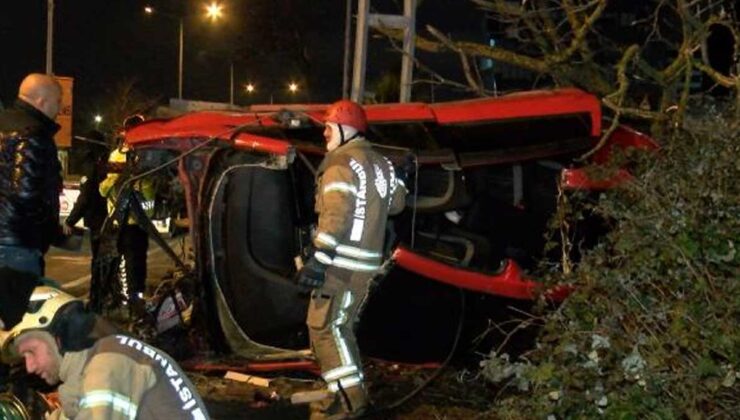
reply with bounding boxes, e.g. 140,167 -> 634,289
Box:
59,335 -> 209,420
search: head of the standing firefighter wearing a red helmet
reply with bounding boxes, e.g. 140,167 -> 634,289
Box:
324,99 -> 367,152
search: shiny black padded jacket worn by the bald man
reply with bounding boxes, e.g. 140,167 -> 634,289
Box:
0,100 -> 62,252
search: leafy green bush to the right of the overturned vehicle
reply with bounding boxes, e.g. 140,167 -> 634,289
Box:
482,102 -> 740,419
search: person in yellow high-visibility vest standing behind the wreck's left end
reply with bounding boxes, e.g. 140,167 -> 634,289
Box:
100,145 -> 155,303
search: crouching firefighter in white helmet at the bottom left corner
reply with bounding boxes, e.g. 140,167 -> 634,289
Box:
2,286 -> 209,420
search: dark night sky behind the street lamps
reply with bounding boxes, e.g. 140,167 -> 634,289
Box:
0,0 -> 483,132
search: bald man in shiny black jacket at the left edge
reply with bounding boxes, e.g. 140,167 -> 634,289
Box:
0,73 -> 63,282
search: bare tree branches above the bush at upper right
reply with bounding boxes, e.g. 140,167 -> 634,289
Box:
379,0 -> 740,131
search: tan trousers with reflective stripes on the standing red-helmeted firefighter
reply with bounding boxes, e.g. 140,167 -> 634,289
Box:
306,267 -> 375,418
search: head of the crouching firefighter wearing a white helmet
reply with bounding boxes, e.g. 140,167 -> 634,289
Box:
2,286 -> 89,385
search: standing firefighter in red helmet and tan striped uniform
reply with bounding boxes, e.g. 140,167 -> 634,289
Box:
298,100 -> 406,419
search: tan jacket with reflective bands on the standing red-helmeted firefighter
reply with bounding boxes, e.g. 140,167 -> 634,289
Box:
314,139 -> 406,272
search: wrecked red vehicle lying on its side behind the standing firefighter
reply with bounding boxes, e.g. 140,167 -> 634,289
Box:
125,89 -> 655,359
